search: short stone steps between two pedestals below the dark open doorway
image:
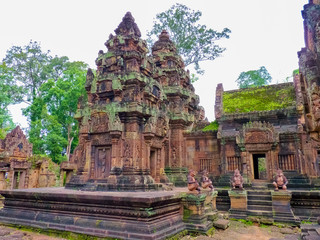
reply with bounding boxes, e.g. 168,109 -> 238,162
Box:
247,189 -> 273,222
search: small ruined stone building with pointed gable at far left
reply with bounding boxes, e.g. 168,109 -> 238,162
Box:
0,126 -> 56,190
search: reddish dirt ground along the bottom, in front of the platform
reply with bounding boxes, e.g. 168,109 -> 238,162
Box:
0,221 -> 299,240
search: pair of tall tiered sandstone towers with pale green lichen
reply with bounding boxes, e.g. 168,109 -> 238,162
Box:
66,12 -> 201,190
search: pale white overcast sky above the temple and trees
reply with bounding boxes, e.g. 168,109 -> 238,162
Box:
0,0 -> 308,128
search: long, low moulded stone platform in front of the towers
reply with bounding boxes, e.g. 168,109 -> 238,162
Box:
0,188 -> 185,239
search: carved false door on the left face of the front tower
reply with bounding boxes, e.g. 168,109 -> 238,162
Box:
94,147 -> 111,179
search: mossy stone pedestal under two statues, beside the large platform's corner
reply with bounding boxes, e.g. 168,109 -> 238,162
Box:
182,190 -> 217,233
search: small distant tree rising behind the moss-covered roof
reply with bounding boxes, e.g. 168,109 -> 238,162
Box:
236,66 -> 272,88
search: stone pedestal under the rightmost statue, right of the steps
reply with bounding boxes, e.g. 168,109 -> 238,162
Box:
271,190 -> 300,225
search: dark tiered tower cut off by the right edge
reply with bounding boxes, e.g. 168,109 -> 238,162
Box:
294,0 -> 320,177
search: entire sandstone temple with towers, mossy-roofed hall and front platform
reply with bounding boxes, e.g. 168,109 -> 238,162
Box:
0,0 -> 320,239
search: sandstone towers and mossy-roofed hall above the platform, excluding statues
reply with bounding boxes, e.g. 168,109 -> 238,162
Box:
62,1 -> 320,190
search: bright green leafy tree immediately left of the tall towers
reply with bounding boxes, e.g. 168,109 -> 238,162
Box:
24,57 -> 87,163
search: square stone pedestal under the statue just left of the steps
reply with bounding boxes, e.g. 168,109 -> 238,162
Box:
228,190 -> 247,219
